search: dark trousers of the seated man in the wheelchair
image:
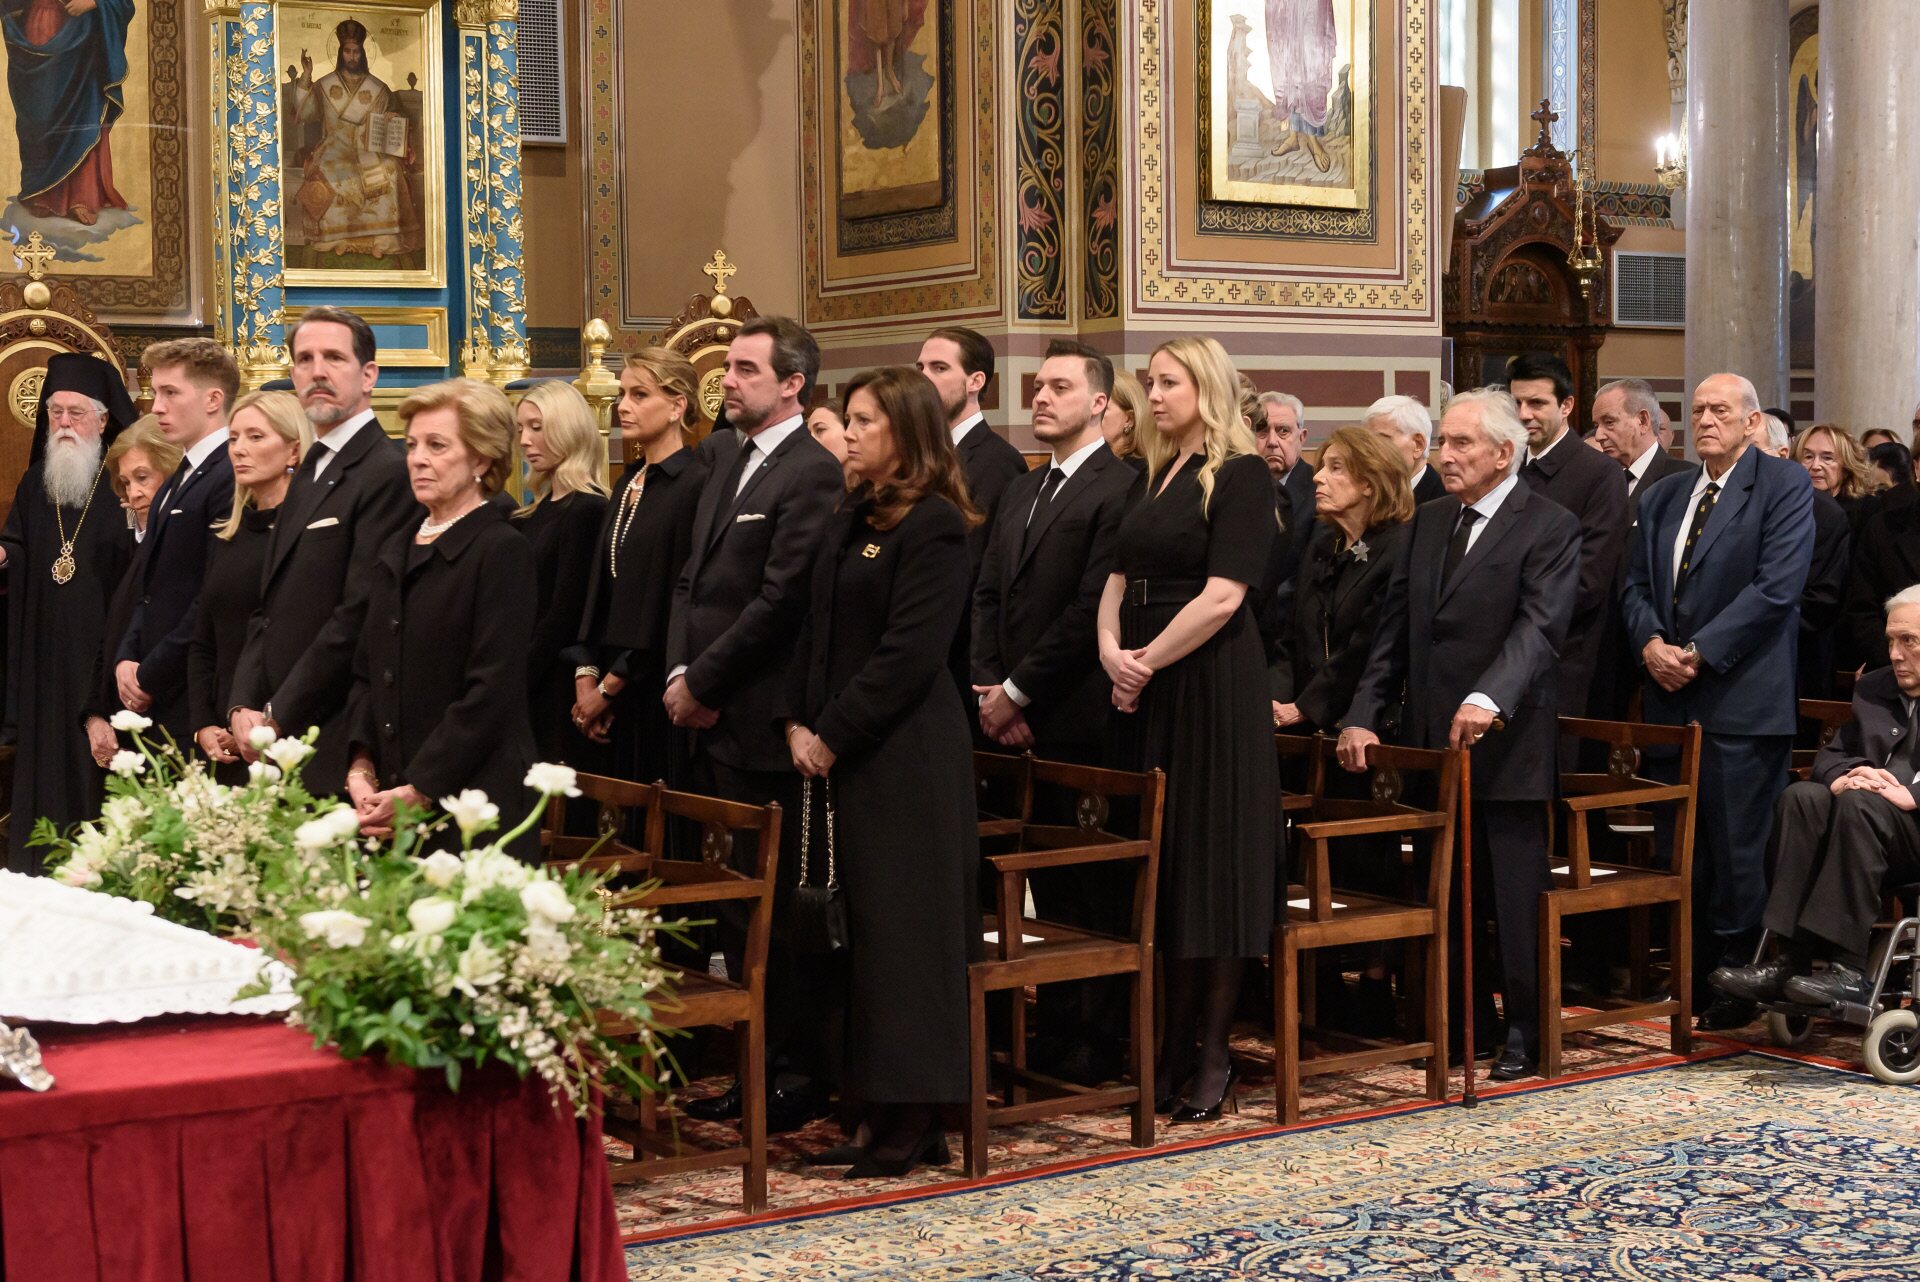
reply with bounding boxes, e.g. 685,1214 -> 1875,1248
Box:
1764,783 -> 1920,963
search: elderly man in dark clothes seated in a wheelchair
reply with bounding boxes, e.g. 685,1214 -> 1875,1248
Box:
1711,585 -> 1920,1006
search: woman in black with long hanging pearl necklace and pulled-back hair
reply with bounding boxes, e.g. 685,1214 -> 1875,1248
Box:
563,347 -> 707,787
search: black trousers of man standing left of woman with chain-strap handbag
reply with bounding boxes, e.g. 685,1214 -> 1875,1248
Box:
701,758 -> 847,1086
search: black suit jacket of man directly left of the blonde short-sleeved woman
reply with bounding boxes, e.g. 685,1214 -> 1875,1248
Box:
972,445 -> 1140,756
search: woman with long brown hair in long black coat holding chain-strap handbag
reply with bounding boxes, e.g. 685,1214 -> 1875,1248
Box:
787,367 -> 979,1178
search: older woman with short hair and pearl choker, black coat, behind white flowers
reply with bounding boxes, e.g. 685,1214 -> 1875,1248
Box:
348,378 -> 540,860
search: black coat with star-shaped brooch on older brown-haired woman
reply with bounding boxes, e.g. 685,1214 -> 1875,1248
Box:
1269,522 -> 1413,731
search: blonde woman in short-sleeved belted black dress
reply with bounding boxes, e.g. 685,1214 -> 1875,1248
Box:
1100,338 -> 1281,1121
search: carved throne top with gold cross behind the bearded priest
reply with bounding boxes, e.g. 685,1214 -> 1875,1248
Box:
0,232 -> 127,522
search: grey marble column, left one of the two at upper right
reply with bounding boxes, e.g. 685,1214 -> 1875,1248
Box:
1686,0 -> 1789,416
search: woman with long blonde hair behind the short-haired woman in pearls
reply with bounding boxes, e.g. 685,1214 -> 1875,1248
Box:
513,378 -> 607,773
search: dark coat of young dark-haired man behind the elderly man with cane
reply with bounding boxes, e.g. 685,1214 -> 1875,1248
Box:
1521,428 -> 1628,716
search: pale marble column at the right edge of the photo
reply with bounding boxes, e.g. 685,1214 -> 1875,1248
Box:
1812,0 -> 1920,438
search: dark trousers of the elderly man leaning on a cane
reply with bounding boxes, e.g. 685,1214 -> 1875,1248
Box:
1448,800 -> 1551,1052
